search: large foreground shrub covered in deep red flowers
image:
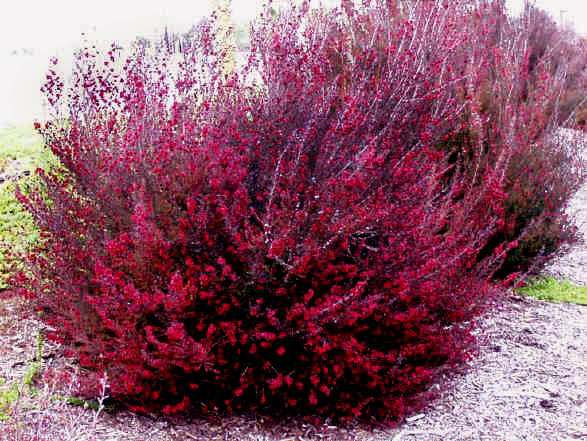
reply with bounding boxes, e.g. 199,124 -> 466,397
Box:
13,1 -> 577,419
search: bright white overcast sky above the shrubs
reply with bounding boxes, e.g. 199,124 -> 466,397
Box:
0,0 -> 587,51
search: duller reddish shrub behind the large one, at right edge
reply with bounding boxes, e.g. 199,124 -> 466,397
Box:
468,5 -> 587,276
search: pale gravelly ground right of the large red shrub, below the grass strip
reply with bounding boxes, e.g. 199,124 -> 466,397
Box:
389,295 -> 587,441
